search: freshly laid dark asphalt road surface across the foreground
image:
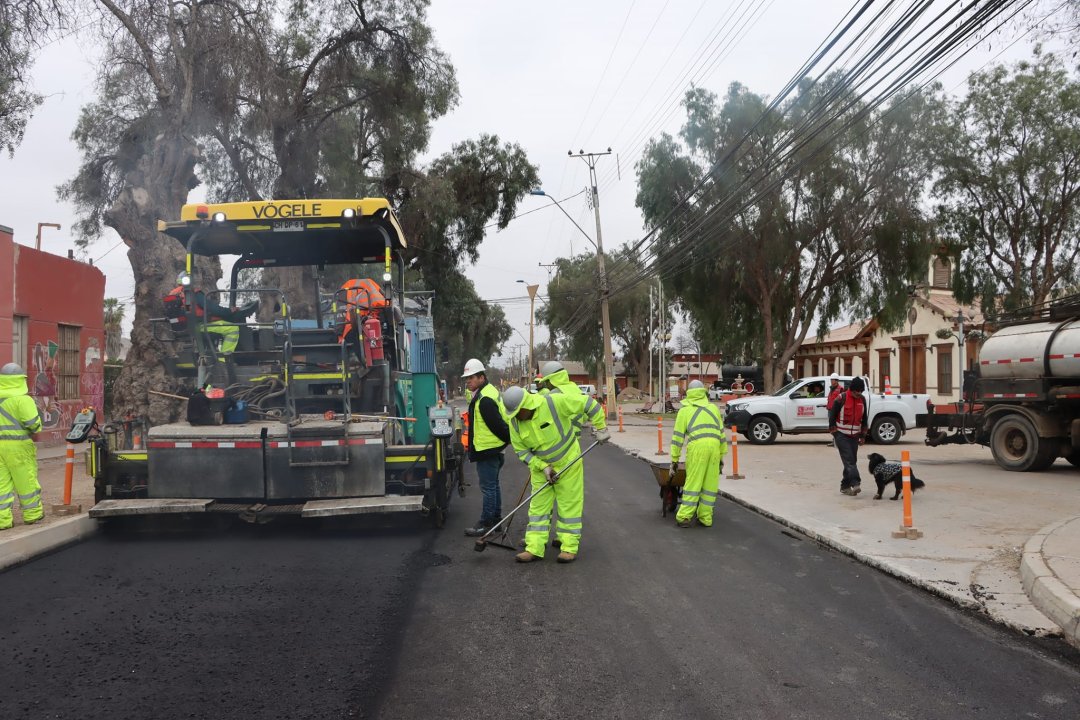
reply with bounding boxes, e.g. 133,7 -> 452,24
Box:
0,447 -> 1080,720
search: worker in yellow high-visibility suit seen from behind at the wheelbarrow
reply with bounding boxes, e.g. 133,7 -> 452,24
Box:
671,380 -> 728,528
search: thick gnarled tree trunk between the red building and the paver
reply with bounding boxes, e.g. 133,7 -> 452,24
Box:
106,135 -> 200,425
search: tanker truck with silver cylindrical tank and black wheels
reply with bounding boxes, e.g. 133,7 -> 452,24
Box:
926,295 -> 1080,472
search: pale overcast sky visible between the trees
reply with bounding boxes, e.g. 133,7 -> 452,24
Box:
0,0 -> 1054,369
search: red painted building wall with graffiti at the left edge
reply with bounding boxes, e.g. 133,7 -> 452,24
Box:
0,233 -> 105,445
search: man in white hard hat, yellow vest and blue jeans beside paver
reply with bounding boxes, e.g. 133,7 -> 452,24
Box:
461,358 -> 510,538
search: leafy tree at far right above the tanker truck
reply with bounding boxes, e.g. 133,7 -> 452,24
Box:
933,52 -> 1080,311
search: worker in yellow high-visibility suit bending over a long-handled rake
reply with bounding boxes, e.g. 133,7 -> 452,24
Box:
502,385 -> 611,562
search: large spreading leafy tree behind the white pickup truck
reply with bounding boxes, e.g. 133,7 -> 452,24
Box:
637,77 -> 936,390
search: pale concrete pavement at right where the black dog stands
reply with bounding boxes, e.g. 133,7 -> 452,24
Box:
611,413 -> 1080,647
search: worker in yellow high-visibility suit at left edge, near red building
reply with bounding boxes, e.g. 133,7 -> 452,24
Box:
0,363 -> 45,530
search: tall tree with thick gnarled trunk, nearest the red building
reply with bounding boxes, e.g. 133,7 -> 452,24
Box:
60,0 -> 271,423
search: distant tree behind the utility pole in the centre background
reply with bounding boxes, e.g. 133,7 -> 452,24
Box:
537,248 -> 651,388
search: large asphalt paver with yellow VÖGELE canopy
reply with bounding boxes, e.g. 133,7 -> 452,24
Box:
72,199 -> 463,526
